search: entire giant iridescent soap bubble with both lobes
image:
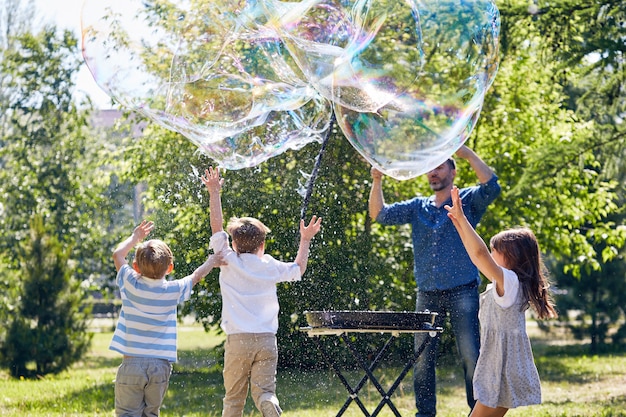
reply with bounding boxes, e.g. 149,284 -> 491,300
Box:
83,0 -> 500,179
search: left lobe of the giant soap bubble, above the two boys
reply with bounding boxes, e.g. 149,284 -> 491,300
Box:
83,0 -> 331,169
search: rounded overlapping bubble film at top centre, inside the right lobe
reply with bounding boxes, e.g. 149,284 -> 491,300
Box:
263,0 -> 424,112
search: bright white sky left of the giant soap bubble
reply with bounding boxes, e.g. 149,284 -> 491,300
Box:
35,0 -> 112,108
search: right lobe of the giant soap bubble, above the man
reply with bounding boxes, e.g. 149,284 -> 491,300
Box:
265,0 -> 500,179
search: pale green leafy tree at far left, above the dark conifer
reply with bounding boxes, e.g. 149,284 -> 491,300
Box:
0,28 -> 113,286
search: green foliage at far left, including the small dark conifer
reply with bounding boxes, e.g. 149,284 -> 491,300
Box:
0,27 -> 109,376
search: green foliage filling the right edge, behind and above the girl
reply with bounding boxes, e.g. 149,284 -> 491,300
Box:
477,0 -> 626,349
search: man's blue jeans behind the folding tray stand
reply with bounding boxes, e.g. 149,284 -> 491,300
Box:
413,284 -> 480,417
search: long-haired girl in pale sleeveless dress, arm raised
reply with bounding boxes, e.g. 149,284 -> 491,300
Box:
445,187 -> 557,417
